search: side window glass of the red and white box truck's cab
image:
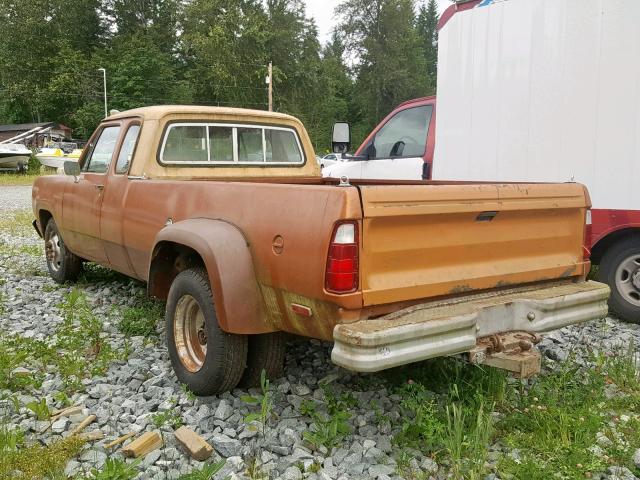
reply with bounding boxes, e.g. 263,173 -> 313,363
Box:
372,105 -> 433,159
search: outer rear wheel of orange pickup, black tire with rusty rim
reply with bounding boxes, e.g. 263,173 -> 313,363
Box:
166,268 -> 247,396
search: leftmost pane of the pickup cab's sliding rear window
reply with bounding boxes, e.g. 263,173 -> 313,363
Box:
162,125 -> 208,163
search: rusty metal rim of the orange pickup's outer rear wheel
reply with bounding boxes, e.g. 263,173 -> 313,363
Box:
173,295 -> 207,373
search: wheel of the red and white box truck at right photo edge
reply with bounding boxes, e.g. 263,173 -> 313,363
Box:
598,236 -> 640,323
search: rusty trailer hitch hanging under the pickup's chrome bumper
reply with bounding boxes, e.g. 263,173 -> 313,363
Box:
469,332 -> 541,378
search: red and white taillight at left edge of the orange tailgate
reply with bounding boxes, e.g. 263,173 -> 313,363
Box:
325,222 -> 359,293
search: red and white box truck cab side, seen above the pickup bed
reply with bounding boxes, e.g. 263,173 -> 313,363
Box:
322,96 -> 436,180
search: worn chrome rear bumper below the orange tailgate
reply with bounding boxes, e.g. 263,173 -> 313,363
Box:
331,281 -> 610,372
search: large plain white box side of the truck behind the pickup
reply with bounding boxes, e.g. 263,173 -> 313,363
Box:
433,0 -> 640,210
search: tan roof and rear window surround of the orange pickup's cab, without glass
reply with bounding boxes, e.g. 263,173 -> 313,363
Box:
109,105 -> 320,179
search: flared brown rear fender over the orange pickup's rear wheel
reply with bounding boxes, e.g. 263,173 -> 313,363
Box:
148,218 -> 276,334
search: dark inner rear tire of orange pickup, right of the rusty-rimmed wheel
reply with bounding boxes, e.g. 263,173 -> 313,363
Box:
238,332 -> 287,388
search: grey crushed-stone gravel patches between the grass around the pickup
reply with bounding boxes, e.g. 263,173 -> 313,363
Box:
0,187 -> 640,479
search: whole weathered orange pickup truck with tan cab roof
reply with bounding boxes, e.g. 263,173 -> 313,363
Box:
33,106 -> 609,395
